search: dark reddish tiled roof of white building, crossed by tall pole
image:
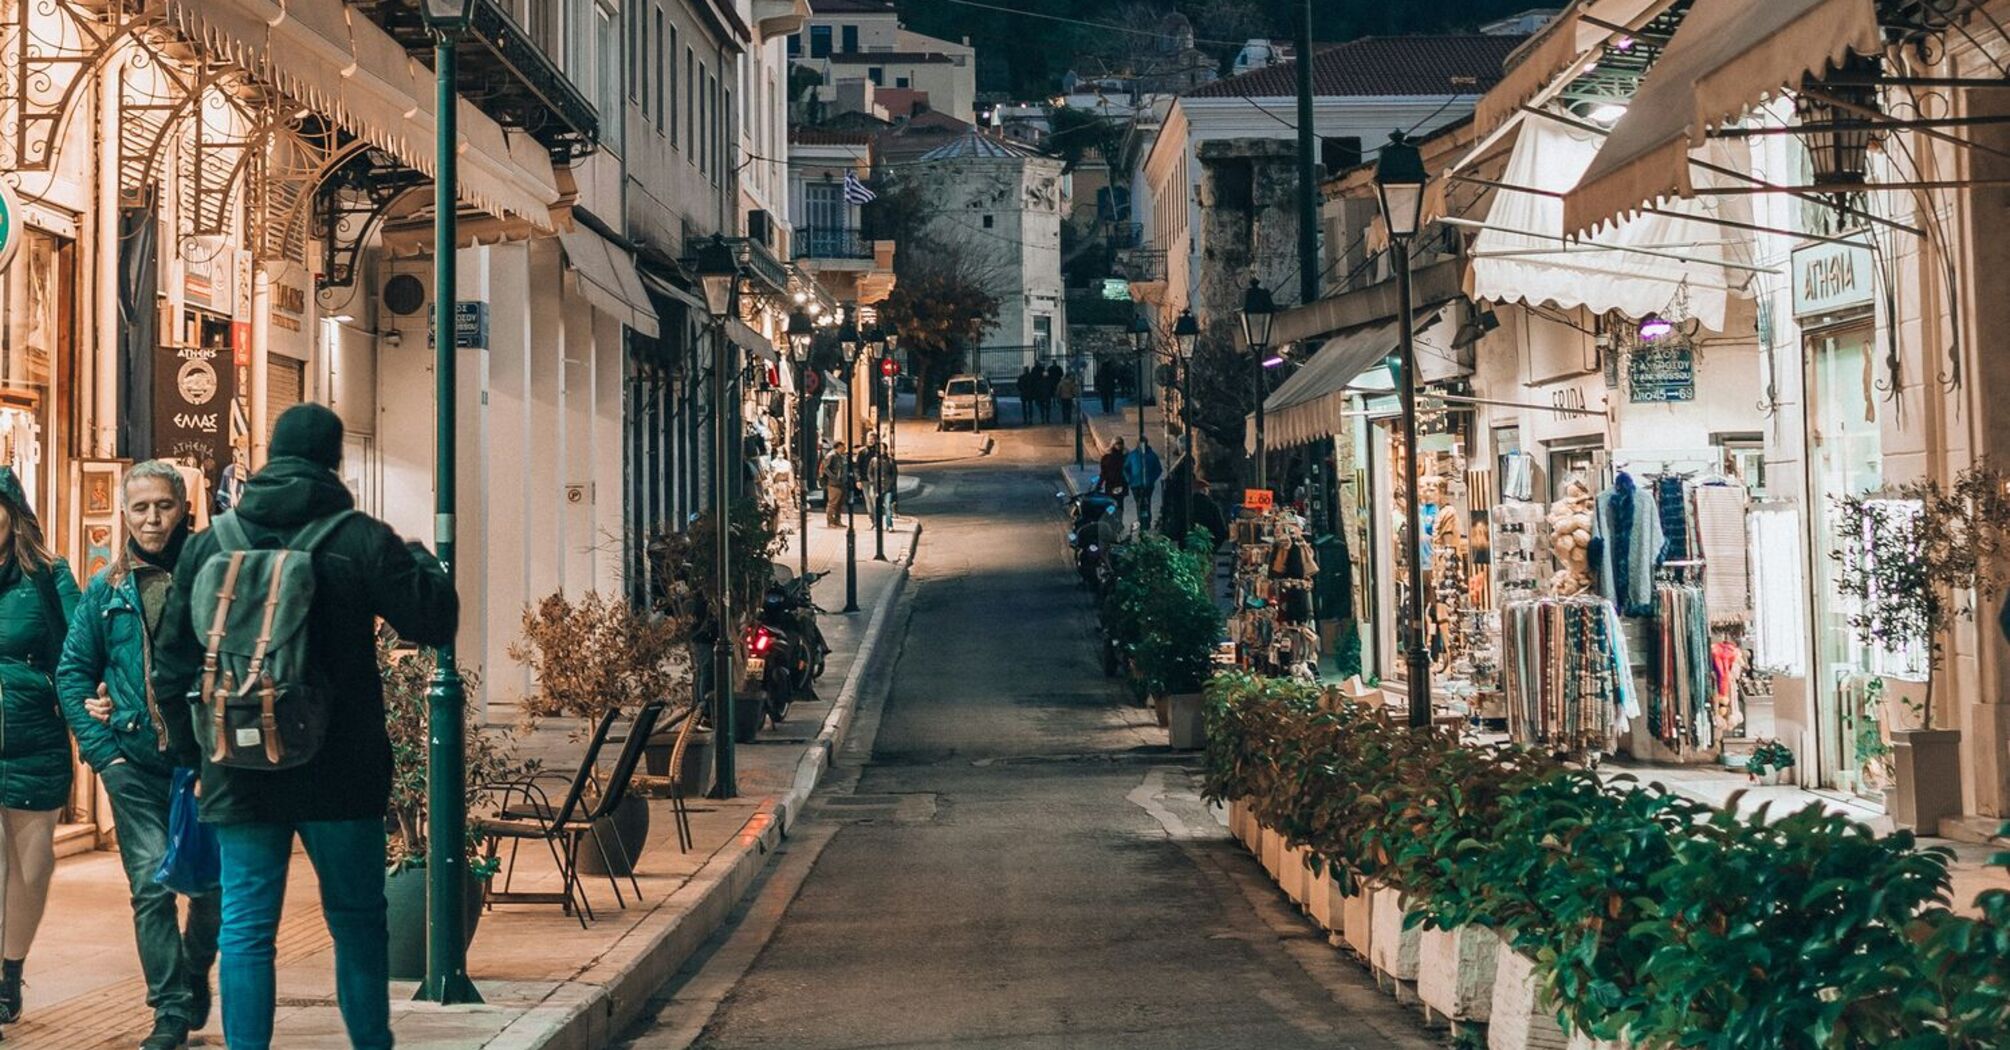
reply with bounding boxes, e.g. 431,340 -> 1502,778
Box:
1186,32 -> 1526,99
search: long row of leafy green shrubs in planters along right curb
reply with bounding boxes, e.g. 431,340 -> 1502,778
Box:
1206,674 -> 2010,1050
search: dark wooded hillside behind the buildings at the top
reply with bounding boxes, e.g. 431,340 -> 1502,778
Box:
896,0 -> 1535,99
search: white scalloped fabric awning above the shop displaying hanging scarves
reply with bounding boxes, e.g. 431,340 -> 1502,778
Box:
1467,117 -> 1749,332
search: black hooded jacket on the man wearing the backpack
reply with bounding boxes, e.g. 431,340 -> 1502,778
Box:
153,457 -> 460,825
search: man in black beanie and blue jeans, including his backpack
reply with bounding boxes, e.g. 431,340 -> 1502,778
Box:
153,404 -> 460,1050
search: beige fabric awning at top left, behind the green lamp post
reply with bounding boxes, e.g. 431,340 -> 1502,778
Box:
165,0 -> 561,229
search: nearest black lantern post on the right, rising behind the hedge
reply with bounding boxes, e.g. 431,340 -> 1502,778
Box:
1375,131 -> 1431,728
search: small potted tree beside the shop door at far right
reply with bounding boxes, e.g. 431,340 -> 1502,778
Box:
1829,465 -> 2010,833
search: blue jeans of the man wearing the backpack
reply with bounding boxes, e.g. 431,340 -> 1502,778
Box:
217,819 -> 392,1050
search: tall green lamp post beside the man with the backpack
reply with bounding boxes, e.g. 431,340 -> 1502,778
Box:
416,0 -> 482,1006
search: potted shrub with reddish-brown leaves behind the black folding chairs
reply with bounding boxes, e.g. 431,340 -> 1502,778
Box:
509,591 -> 687,875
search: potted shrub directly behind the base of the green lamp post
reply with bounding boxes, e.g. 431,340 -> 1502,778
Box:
378,638 -> 535,980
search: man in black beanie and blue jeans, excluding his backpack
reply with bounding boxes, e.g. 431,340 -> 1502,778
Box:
153,404 -> 460,1050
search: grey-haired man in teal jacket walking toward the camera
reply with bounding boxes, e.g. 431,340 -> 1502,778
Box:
56,459 -> 221,1050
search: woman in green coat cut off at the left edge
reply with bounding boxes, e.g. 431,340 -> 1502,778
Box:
0,467 -> 76,1024
